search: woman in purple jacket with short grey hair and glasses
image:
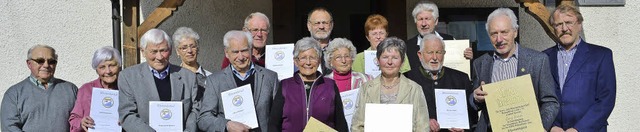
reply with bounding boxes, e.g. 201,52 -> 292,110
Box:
269,37 -> 348,132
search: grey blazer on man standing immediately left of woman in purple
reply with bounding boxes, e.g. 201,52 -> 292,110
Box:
198,65 -> 280,132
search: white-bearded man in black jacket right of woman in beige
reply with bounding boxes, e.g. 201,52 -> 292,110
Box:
404,34 -> 478,132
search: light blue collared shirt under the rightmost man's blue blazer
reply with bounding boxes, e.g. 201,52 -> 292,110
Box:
556,39 -> 582,92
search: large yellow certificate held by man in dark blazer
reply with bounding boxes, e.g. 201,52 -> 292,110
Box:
482,74 -> 545,132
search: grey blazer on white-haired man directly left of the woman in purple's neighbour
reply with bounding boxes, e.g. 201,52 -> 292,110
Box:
118,62 -> 197,132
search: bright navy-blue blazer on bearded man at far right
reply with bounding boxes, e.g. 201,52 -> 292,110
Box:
544,40 -> 616,132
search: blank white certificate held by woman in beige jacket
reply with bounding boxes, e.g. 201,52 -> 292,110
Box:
364,103 -> 412,132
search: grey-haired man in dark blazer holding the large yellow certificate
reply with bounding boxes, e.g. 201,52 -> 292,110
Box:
469,8 -> 559,132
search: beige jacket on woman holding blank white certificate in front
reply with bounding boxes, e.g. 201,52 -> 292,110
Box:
351,74 -> 429,132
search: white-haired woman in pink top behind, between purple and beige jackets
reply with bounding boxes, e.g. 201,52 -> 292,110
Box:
324,38 -> 373,92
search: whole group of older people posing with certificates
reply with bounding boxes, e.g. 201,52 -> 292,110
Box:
0,1 -> 616,132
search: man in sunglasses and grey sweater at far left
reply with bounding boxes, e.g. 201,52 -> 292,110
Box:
0,45 -> 78,132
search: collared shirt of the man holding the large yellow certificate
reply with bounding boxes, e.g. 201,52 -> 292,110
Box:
491,43 -> 520,82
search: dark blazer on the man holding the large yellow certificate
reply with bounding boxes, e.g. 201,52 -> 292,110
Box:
469,44 -> 559,132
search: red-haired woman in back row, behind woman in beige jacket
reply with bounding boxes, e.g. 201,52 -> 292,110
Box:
352,14 -> 411,73
